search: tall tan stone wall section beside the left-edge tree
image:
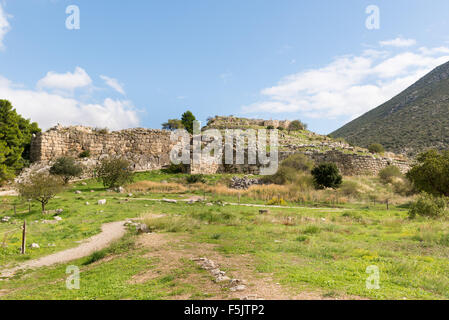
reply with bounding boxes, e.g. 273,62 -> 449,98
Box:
31,127 -> 173,171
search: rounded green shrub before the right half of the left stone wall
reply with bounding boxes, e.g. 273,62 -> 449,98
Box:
95,158 -> 133,188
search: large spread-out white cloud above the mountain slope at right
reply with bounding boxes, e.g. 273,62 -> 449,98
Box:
242,43 -> 449,119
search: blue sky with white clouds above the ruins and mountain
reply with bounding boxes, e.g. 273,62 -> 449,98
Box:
0,0 -> 449,134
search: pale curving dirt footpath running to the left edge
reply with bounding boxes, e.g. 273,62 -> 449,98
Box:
0,221 -> 126,277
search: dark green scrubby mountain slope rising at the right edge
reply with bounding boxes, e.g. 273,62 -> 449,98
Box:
331,62 -> 449,155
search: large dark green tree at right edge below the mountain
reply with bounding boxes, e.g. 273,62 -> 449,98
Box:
407,150 -> 449,197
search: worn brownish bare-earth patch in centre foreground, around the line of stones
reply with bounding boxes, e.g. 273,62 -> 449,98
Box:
130,233 -> 360,300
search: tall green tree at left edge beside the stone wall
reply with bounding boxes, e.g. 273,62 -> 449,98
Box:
0,100 -> 40,183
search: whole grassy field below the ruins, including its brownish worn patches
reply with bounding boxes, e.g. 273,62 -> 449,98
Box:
0,172 -> 449,299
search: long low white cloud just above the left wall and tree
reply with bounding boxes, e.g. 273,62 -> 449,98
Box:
0,70 -> 139,130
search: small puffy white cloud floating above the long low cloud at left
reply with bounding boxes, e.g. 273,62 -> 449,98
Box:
37,67 -> 92,92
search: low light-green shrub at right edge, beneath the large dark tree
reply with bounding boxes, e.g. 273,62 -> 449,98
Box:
409,193 -> 447,218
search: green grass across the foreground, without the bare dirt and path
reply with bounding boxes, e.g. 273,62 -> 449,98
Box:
0,172 -> 449,299
